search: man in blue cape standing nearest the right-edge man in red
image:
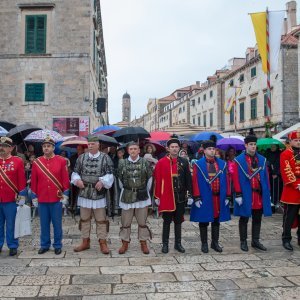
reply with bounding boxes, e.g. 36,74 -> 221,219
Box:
232,135 -> 272,251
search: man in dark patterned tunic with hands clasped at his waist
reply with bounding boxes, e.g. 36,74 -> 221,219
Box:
71,135 -> 114,254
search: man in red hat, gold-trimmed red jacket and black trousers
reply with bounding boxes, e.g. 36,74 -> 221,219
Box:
280,129 -> 300,251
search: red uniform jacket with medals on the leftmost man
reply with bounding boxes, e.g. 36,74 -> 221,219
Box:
0,156 -> 26,202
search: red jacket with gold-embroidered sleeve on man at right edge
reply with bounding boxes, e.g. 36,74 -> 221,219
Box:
280,149 -> 300,204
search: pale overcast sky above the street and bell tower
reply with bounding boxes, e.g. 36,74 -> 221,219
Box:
101,0 -> 300,124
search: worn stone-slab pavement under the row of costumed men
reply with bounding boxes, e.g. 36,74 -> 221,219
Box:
0,214 -> 300,300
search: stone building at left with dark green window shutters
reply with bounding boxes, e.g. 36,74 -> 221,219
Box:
0,0 -> 107,134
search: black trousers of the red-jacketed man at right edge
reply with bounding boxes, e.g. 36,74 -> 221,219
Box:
282,204 -> 300,242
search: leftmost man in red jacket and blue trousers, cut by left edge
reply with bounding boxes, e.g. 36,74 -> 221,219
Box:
0,137 -> 26,256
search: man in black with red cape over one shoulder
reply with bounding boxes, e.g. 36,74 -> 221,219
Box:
154,138 -> 192,253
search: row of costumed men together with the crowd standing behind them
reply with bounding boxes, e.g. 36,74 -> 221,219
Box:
0,131 -> 300,256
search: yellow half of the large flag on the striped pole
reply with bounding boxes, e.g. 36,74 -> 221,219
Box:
251,12 -> 268,73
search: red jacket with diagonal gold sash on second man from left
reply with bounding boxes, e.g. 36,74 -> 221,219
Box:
31,155 -> 70,203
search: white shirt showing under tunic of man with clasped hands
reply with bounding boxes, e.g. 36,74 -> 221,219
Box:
71,151 -> 114,209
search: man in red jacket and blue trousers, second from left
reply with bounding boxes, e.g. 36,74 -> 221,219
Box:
31,137 -> 70,255
